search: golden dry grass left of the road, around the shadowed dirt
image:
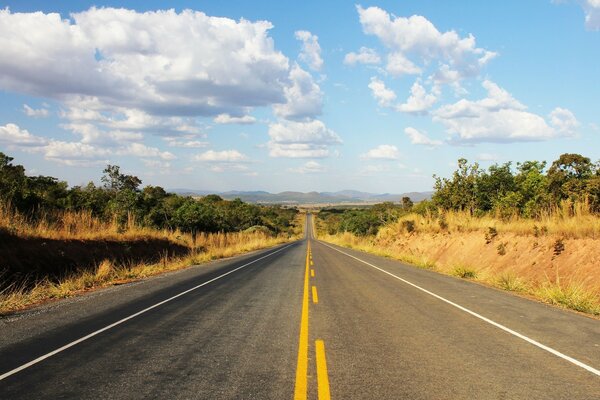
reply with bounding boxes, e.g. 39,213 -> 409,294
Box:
0,206 -> 302,315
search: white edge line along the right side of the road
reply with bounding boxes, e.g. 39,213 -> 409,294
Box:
319,241 -> 600,376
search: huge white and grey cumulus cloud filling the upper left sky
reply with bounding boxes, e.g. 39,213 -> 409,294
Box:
0,8 -> 290,116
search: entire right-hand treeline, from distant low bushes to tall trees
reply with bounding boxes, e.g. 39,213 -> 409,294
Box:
318,154 -> 600,236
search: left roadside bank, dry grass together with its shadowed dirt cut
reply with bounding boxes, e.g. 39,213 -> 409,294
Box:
0,206 -> 300,315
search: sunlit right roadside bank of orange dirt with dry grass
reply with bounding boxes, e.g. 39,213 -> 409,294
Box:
319,215 -> 600,315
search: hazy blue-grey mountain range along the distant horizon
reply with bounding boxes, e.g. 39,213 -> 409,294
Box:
171,189 -> 433,204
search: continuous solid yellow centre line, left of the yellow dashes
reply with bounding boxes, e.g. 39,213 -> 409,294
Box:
294,241 -> 310,400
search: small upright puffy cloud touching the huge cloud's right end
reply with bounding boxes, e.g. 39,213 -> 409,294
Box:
273,64 -> 323,120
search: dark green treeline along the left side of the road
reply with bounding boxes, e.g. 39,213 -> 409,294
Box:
0,152 -> 298,234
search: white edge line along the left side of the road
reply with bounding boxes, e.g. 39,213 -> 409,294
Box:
0,243 -> 294,381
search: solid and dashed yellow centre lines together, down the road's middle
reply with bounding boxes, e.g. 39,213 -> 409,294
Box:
294,241 -> 331,400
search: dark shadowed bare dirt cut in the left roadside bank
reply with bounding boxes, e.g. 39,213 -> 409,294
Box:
0,230 -> 189,290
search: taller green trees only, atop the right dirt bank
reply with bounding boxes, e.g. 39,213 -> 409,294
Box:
432,154 -> 600,219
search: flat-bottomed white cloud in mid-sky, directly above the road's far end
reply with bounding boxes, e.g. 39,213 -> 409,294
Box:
267,120 -> 342,158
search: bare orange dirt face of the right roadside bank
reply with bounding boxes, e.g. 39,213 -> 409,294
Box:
374,228 -> 600,293
